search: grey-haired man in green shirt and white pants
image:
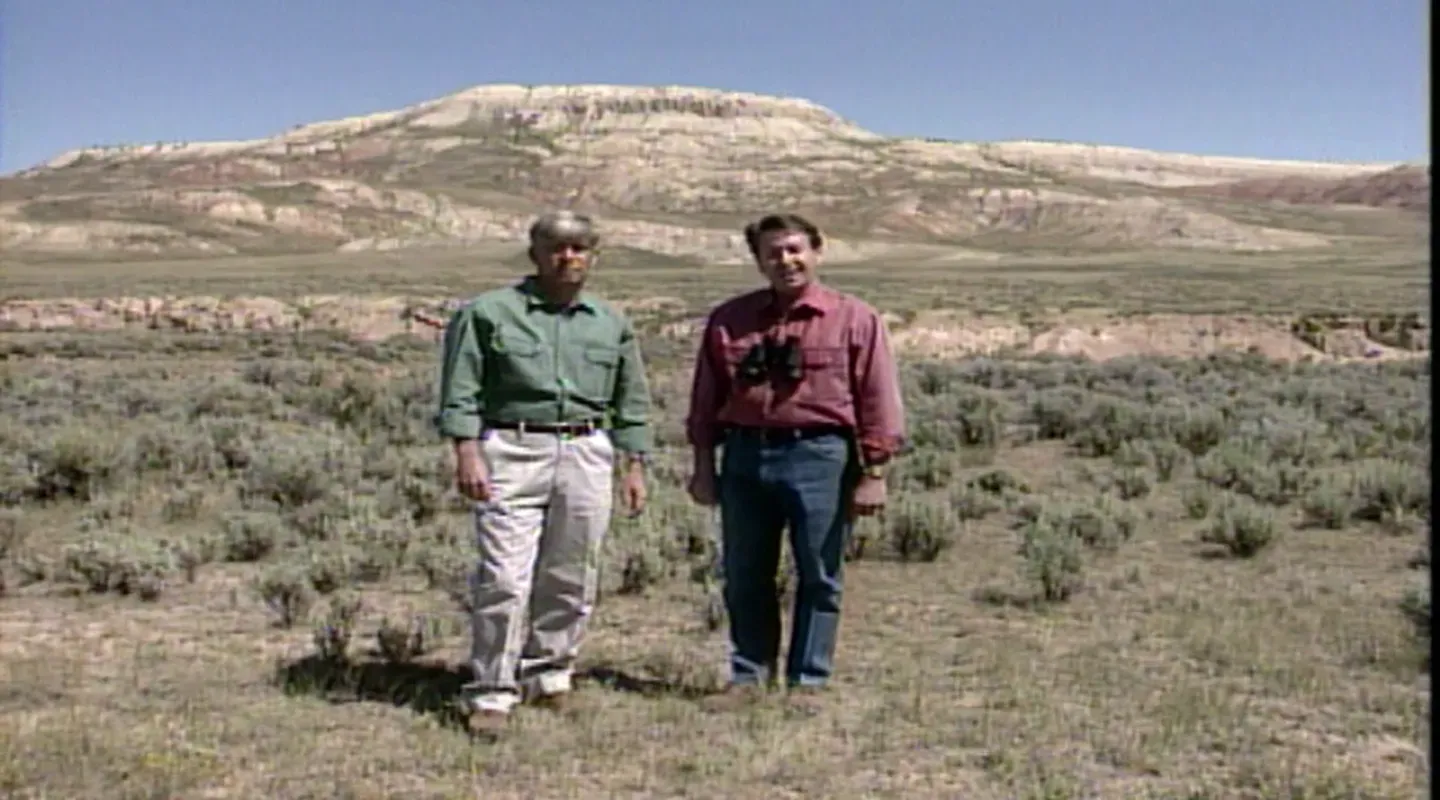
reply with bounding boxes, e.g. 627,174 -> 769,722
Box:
435,212 -> 651,735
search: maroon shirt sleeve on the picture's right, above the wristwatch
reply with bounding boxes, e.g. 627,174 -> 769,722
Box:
854,311 -> 906,463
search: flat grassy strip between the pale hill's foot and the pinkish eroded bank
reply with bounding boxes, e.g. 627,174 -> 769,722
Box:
0,245 -> 1430,317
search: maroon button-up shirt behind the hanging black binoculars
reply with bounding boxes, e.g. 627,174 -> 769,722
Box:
685,285 -> 904,463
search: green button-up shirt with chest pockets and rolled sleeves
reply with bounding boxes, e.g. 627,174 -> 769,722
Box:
435,278 -> 651,453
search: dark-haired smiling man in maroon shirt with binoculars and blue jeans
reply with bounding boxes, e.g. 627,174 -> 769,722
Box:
687,214 -> 904,706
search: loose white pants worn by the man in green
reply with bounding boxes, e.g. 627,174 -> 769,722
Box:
465,430 -> 615,711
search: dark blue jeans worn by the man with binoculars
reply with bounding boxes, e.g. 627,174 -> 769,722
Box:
719,433 -> 855,686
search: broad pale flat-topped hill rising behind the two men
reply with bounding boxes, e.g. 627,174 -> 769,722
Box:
0,85 -> 1428,260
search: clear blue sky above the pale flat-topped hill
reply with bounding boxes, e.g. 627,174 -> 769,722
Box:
0,0 -> 1430,173
